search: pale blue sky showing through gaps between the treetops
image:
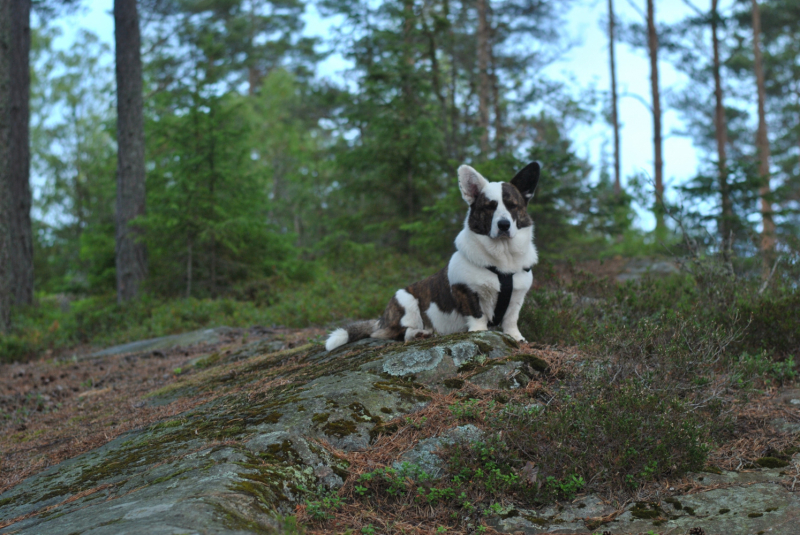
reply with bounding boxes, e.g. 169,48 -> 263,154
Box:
47,0 -> 730,230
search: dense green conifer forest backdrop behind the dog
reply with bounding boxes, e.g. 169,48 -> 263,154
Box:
0,0 -> 800,358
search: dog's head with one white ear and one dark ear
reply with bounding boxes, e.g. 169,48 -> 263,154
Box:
458,162 -> 539,239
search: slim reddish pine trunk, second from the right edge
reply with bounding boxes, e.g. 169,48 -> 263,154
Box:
711,0 -> 733,243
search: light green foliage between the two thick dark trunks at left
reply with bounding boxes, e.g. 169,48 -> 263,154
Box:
31,28 -> 117,294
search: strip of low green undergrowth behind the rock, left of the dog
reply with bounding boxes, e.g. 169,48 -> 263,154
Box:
0,255 -> 432,361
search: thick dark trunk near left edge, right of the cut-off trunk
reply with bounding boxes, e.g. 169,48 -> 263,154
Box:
9,0 -> 33,305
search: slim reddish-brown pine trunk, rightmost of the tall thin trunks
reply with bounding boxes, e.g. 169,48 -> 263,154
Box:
751,0 -> 775,277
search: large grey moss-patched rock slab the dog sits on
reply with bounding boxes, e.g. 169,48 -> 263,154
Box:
0,332 -> 517,535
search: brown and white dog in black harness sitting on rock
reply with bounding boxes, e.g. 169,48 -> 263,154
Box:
325,162 -> 539,351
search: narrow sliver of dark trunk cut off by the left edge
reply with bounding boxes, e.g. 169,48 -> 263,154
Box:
0,0 -> 14,333
